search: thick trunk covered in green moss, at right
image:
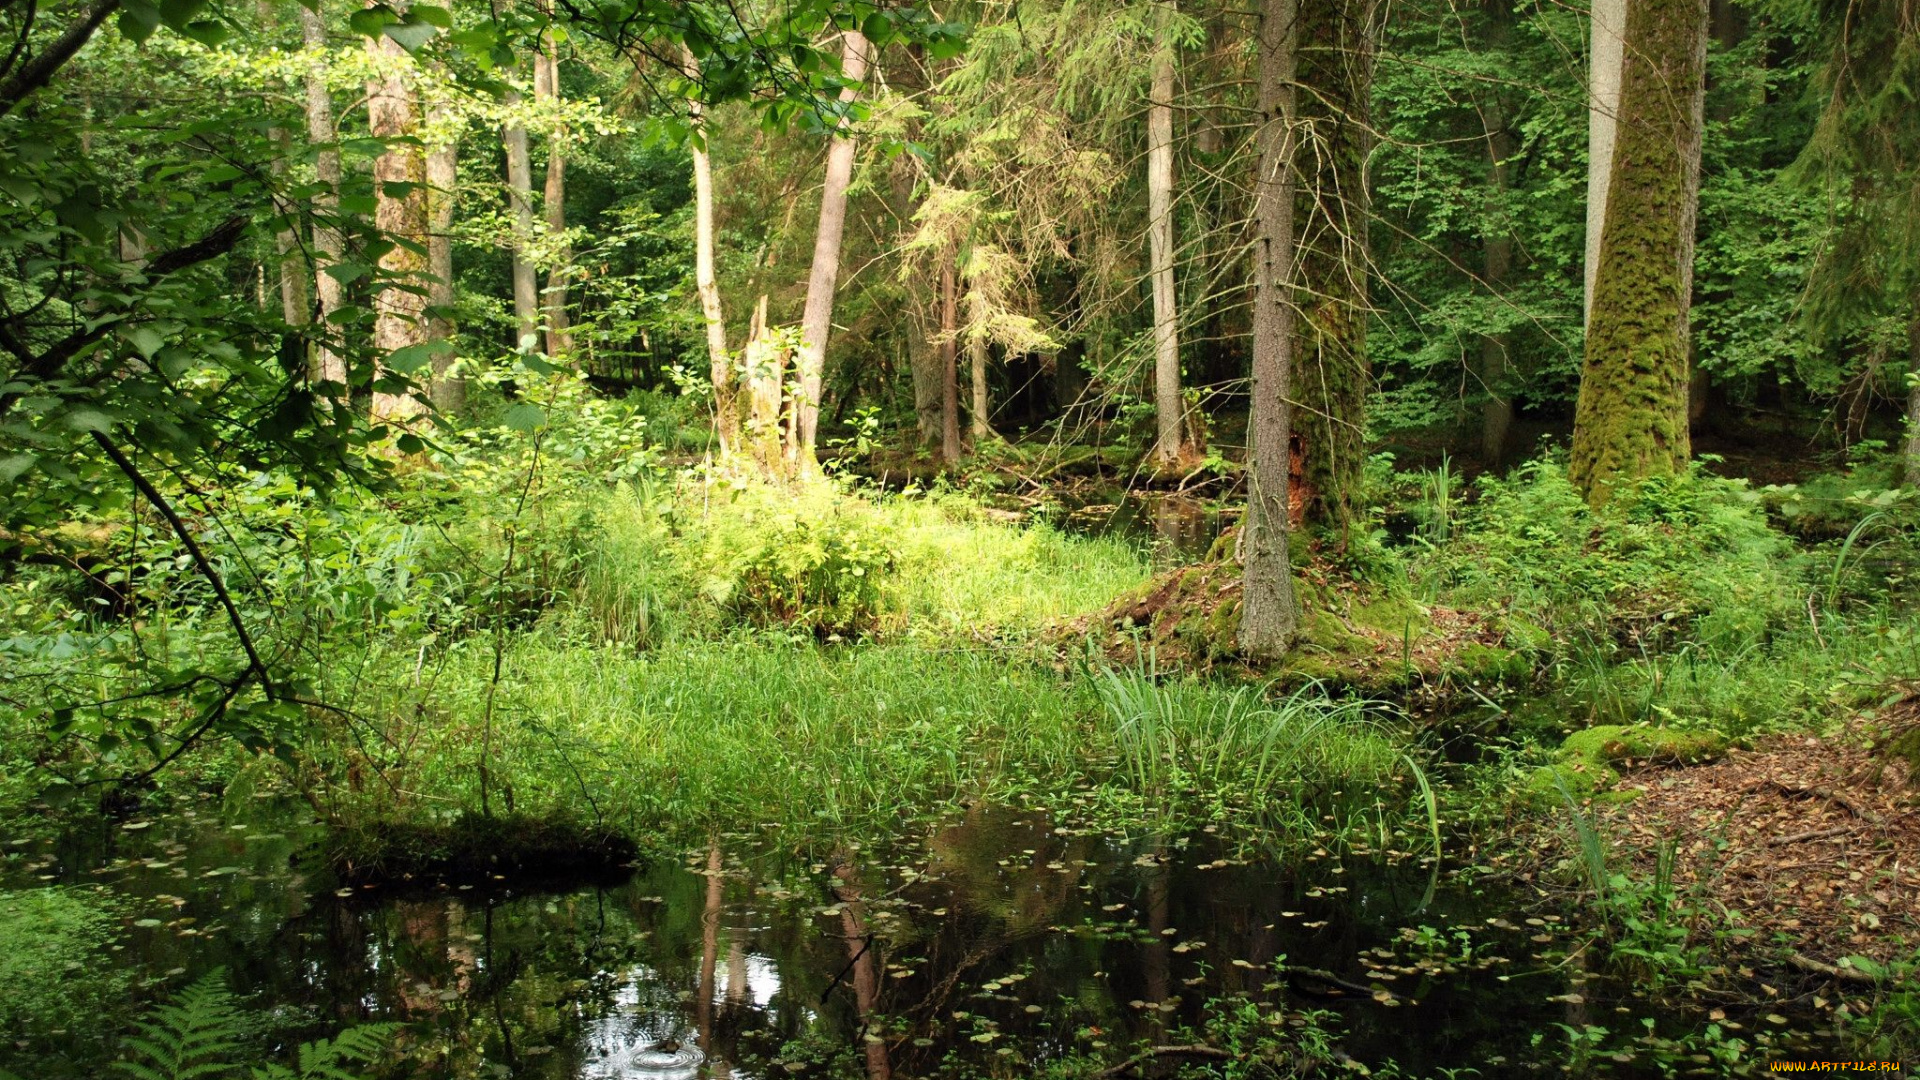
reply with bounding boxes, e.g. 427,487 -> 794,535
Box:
1569,0 -> 1707,505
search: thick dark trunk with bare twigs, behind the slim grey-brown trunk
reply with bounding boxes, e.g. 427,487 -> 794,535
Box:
1292,0 -> 1380,527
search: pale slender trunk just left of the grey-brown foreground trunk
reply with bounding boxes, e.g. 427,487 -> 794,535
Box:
1146,46 -> 1187,467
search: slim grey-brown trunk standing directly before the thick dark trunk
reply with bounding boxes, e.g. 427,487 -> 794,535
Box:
1240,0 -> 1313,661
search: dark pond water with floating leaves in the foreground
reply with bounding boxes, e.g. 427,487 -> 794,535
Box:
0,803 -> 1839,1080
